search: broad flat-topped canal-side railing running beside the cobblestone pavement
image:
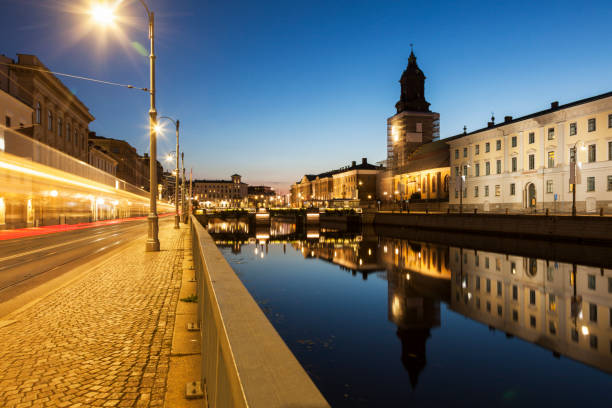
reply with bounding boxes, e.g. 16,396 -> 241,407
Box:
191,216 -> 329,408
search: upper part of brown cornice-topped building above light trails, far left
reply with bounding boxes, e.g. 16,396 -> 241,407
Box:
0,54 -> 94,162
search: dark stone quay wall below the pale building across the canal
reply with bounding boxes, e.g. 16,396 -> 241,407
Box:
373,213 -> 612,243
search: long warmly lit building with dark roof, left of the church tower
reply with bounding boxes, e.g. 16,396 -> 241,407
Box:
291,157 -> 383,207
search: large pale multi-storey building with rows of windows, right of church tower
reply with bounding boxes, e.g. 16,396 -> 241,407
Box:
448,92 -> 612,213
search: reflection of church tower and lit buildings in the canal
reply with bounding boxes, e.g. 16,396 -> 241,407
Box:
209,217 -> 612,380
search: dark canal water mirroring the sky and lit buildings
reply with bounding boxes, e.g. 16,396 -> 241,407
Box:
209,223 -> 612,407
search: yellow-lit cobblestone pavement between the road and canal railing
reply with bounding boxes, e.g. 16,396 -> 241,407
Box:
0,223 -> 188,408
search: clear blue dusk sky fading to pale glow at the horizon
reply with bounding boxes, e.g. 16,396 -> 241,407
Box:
0,0 -> 612,191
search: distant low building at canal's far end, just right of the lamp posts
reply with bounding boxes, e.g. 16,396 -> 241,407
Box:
193,174 -> 248,207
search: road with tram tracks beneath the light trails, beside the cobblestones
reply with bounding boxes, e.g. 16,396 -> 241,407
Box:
0,217 -> 172,317
